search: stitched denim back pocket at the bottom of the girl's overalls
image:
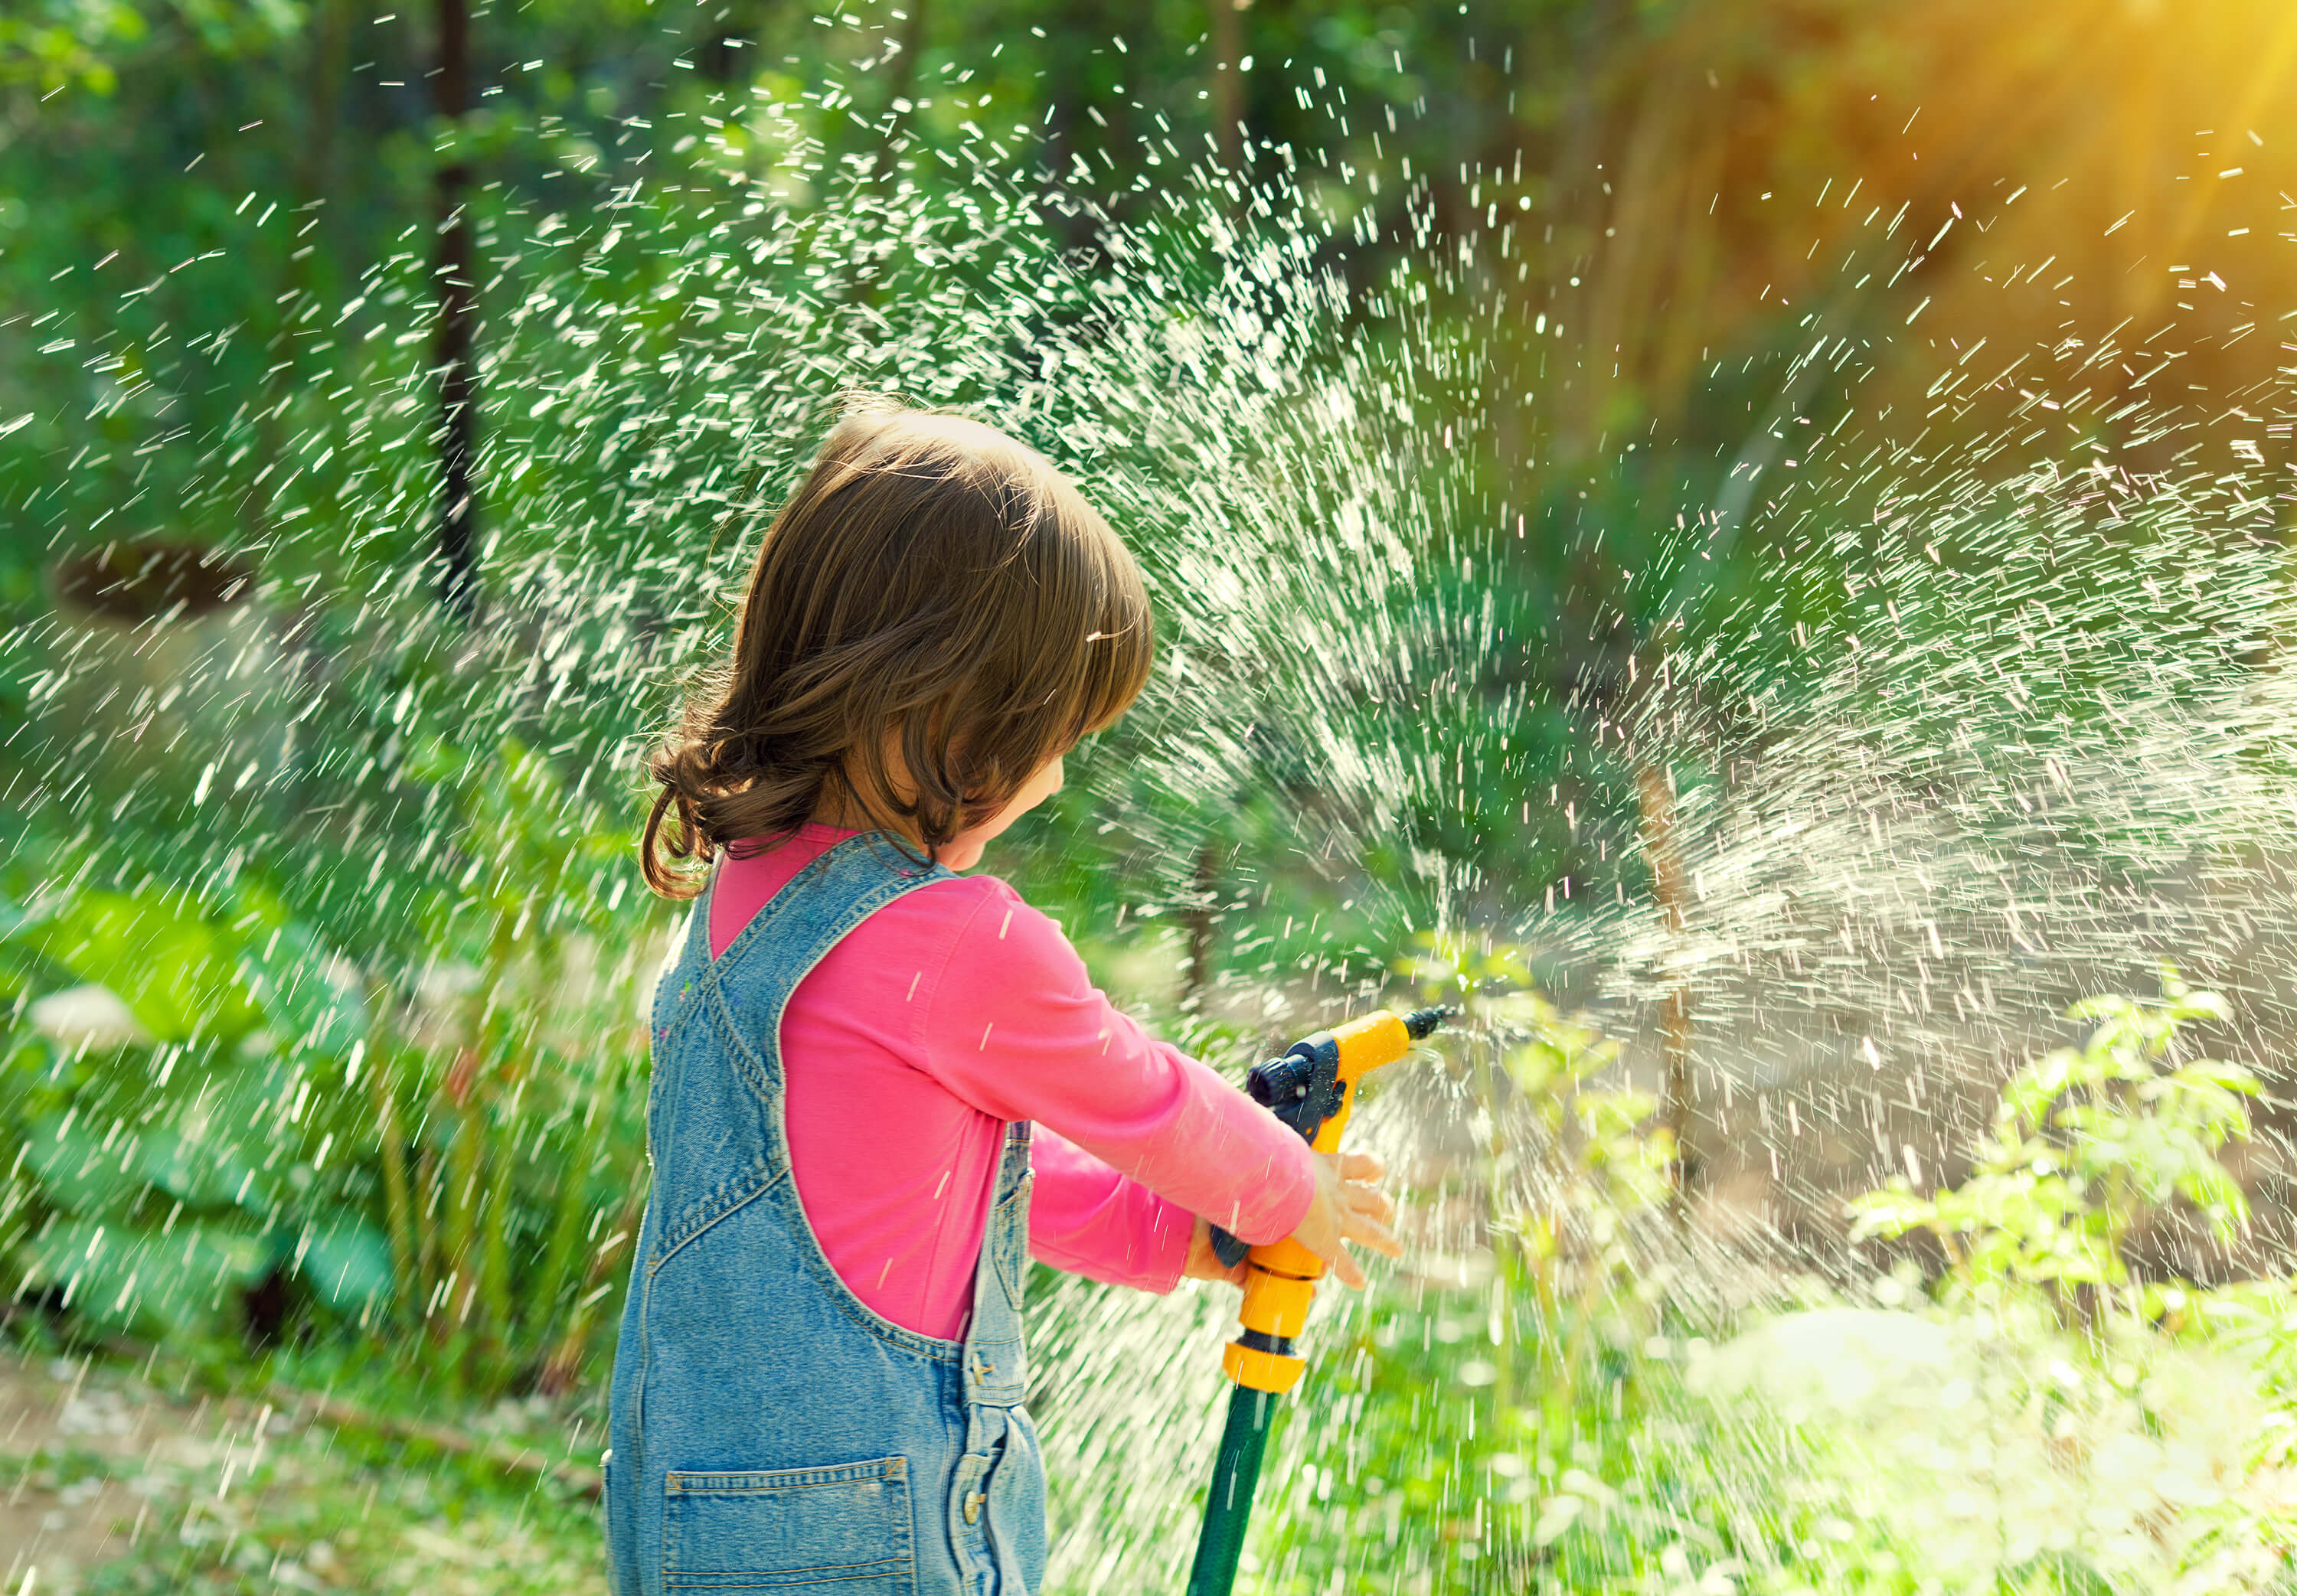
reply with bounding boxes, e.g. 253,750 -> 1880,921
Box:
662,1458 -> 917,1596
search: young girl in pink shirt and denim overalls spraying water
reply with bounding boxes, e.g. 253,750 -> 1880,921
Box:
606,409 -> 1397,1596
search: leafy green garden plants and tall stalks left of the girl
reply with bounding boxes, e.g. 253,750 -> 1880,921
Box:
0,739 -> 655,1392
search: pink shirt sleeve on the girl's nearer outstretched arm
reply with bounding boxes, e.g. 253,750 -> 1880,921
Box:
921,877 -> 1316,1277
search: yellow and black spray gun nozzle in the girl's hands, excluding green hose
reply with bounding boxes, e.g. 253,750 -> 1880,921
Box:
1215,1008 -> 1454,1392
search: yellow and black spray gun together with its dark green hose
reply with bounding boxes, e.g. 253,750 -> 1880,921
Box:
1188,1008 -> 1459,1596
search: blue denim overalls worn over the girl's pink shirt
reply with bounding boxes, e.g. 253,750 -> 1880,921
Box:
606,834 -> 1045,1596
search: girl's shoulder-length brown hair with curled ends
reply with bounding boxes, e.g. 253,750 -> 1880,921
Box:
639,406 -> 1153,898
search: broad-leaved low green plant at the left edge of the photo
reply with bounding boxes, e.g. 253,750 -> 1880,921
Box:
0,854 -> 379,1337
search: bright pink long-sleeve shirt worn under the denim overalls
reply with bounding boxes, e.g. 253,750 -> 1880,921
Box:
710,824 -> 1316,1339
